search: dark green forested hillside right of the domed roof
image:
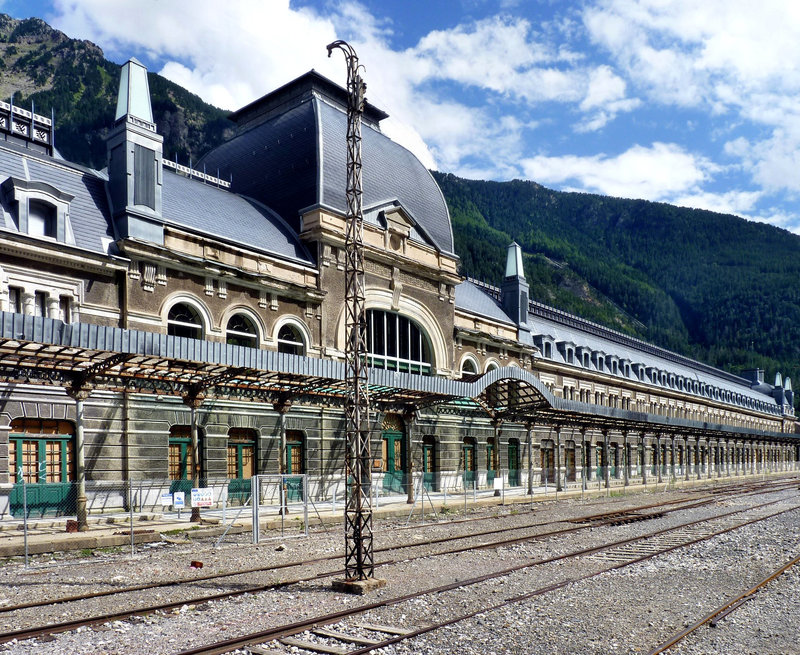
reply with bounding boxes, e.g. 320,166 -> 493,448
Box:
435,173 -> 800,390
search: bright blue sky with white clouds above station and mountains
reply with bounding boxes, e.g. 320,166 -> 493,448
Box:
0,0 -> 800,233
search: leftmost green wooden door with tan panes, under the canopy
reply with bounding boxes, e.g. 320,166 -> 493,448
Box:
9,434 -> 77,517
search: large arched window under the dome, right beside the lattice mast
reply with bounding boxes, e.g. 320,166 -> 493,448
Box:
367,309 -> 432,374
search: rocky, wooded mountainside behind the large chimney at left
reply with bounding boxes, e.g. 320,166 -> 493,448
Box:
0,14 -> 231,168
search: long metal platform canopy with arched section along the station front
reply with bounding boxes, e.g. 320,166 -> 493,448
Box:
0,312 -> 799,441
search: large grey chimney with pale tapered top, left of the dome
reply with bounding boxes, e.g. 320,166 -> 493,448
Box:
106,59 -> 164,244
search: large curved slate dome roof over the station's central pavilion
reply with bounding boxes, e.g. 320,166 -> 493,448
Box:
199,72 -> 453,253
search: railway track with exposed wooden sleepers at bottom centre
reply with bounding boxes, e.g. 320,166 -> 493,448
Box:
173,502 -> 800,655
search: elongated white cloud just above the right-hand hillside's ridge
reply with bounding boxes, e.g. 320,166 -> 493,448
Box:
522,143 -> 718,201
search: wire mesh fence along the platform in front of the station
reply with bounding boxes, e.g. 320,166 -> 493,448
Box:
0,460 -> 798,562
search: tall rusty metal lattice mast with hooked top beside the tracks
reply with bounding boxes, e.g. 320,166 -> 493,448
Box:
328,41 -> 375,580
